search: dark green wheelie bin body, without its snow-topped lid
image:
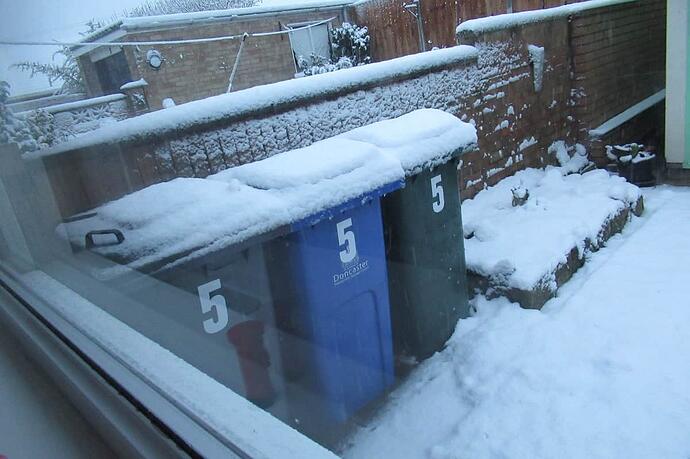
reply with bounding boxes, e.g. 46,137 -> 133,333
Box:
382,148 -> 469,360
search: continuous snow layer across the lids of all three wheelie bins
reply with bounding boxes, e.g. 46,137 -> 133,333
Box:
59,109 -> 477,274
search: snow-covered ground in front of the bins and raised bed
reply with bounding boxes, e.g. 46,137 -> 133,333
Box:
344,187 -> 690,459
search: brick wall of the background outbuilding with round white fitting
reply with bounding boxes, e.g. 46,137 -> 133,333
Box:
80,9 -> 342,110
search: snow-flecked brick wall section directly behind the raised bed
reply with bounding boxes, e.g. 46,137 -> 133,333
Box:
461,20 -> 574,198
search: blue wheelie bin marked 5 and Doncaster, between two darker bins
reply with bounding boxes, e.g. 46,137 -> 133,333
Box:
285,182 -> 397,422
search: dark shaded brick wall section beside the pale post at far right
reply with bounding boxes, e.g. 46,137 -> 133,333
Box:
571,0 -> 666,162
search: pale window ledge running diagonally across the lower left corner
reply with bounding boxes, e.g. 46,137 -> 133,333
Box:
0,271 -> 335,458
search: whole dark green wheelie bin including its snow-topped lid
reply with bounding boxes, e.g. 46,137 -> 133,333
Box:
342,109 -> 477,364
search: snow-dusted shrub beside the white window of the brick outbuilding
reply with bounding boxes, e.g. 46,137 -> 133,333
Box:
297,22 -> 371,75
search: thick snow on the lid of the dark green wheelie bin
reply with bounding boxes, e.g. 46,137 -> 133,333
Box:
338,109 -> 477,175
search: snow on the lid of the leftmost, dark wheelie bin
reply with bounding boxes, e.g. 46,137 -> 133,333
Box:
58,178 -> 290,269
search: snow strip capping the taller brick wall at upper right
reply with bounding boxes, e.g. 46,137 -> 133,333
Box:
455,0 -> 640,35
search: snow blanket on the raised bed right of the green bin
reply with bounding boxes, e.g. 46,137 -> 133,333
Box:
462,155 -> 640,291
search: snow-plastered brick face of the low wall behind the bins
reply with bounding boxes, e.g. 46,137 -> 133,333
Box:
141,43 -> 506,177
